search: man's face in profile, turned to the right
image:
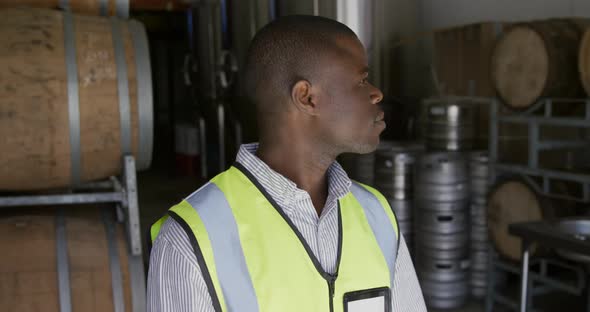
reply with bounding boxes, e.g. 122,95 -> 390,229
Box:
318,37 -> 385,154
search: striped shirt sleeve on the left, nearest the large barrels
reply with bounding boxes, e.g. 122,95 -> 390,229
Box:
147,219 -> 214,312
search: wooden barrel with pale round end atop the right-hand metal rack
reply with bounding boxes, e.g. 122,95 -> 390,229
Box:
491,20 -> 582,110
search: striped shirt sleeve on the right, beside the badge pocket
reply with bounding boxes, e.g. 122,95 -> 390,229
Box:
391,232 -> 426,312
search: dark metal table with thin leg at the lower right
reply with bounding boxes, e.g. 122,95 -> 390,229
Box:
508,221 -> 590,312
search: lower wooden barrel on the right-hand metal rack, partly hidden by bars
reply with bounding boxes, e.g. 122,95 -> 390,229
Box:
487,178 -> 573,261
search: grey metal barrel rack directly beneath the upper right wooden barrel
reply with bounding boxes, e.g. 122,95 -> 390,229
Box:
488,98 -> 590,203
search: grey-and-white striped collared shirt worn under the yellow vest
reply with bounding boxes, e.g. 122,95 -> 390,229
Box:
147,143 -> 426,312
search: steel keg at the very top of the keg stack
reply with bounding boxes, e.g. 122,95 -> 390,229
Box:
426,99 -> 475,151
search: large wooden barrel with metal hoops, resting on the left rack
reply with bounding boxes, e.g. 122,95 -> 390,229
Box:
0,9 -> 153,190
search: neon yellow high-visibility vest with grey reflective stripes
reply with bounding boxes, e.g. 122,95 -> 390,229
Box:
151,167 -> 399,312
